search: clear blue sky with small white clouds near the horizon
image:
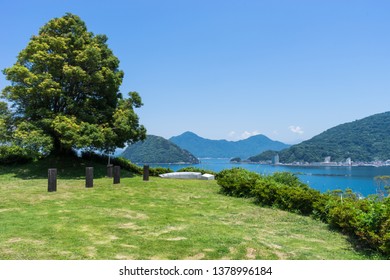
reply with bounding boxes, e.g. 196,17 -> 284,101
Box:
0,0 -> 390,143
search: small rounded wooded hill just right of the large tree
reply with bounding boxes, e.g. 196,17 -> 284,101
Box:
121,135 -> 199,163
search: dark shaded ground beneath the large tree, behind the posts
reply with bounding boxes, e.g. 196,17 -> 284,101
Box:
0,156 -> 135,180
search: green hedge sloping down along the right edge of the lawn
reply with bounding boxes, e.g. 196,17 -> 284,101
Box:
217,168 -> 390,258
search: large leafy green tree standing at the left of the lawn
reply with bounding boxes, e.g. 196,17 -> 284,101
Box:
2,13 -> 146,153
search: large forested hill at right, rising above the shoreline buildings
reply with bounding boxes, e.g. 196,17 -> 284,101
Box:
250,112 -> 390,163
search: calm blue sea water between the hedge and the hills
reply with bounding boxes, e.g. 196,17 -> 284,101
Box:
144,158 -> 390,197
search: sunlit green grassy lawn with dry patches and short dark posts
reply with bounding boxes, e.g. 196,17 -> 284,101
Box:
0,161 -> 378,260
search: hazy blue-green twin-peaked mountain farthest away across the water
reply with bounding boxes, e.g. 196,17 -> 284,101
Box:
169,132 -> 289,159
